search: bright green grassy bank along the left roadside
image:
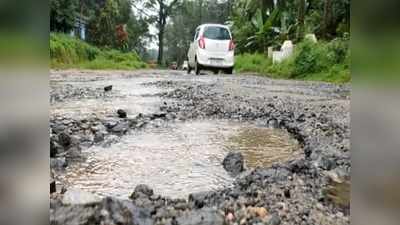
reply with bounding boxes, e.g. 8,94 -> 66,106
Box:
50,33 -> 147,70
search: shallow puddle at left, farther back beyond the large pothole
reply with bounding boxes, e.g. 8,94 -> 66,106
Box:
50,78 -> 172,118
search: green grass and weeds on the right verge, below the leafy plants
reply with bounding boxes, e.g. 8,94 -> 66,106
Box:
235,39 -> 351,83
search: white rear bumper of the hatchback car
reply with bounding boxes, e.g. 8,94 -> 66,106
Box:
197,49 -> 235,68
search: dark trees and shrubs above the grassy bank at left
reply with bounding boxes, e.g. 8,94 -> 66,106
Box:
50,0 -> 149,52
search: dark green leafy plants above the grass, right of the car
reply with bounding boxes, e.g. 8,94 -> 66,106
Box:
231,0 -> 350,53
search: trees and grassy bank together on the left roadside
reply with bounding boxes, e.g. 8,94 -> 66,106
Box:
50,0 -> 149,70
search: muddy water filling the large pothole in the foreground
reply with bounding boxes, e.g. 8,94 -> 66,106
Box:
64,120 -> 298,198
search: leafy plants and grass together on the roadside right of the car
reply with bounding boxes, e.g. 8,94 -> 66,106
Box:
232,0 -> 351,83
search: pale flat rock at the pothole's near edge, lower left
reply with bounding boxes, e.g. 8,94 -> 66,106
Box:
62,189 -> 101,205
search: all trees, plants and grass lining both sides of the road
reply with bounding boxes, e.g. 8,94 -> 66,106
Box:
50,0 -> 351,83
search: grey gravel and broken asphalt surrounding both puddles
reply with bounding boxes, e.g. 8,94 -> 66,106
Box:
50,70 -> 351,225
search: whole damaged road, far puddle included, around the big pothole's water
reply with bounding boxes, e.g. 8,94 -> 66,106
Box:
50,70 -> 351,224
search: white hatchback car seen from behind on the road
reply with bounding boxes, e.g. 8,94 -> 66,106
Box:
187,24 -> 235,75
